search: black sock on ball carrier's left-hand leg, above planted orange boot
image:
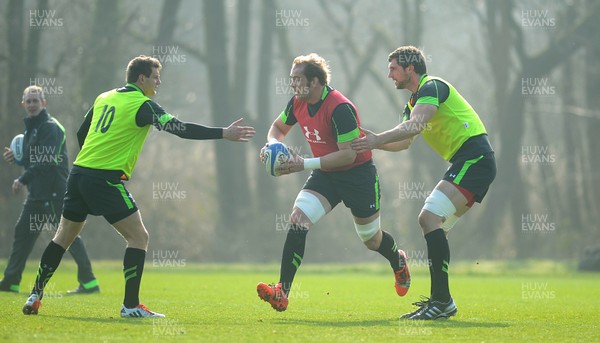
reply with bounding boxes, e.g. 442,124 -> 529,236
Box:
279,224 -> 308,294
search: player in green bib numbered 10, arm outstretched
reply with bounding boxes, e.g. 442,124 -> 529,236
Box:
23,55 -> 255,317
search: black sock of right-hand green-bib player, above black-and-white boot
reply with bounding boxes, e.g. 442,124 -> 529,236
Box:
425,229 -> 450,302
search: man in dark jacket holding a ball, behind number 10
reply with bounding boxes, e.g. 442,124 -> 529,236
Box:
0,86 -> 100,294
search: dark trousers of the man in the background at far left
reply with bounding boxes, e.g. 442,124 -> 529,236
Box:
2,200 -> 95,287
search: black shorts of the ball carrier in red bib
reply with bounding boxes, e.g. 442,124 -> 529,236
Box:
302,161 -> 381,218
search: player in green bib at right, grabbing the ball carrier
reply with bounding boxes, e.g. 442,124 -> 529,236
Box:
352,46 -> 496,320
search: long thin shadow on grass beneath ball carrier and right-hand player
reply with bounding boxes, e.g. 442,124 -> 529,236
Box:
275,317 -> 510,328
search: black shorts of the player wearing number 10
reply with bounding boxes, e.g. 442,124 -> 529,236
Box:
63,166 -> 138,224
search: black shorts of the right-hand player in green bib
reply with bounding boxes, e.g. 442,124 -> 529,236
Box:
443,151 -> 496,203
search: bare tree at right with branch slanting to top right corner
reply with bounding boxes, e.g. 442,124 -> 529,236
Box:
477,0 -> 600,257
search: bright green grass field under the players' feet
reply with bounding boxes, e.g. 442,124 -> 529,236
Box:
0,261 -> 600,342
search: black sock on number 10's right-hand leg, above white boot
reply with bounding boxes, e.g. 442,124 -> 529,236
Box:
123,248 -> 146,308
